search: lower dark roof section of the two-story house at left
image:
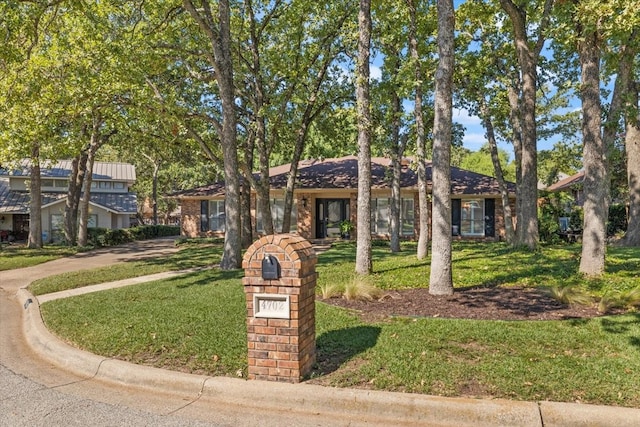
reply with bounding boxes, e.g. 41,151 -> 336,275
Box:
0,179 -> 137,215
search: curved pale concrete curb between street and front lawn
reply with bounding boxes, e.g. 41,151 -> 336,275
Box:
16,288 -> 640,427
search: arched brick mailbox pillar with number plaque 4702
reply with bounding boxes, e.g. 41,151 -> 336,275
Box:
242,234 -> 317,383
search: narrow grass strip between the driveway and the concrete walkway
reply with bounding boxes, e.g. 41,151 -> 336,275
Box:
29,244 -> 222,295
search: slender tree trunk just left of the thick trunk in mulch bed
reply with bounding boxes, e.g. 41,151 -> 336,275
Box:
407,0 -> 429,259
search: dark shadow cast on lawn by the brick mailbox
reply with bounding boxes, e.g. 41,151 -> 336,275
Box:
314,326 -> 382,375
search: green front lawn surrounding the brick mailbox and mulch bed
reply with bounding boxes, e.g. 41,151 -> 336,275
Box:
42,243 -> 640,408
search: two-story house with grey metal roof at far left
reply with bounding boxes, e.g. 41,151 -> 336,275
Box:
0,160 -> 137,242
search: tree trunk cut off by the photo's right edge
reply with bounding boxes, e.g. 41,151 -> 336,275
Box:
623,83 -> 640,246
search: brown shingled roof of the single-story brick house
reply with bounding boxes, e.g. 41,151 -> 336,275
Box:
171,156 -> 515,198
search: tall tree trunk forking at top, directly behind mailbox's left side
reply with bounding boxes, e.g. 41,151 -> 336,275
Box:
183,0 -> 241,270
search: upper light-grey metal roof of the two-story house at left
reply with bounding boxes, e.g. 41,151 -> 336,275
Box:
0,160 -> 136,182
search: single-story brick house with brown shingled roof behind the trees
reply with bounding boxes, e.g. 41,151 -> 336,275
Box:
171,156 -> 515,244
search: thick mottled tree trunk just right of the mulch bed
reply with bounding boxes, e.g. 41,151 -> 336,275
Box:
578,31 -> 609,277
